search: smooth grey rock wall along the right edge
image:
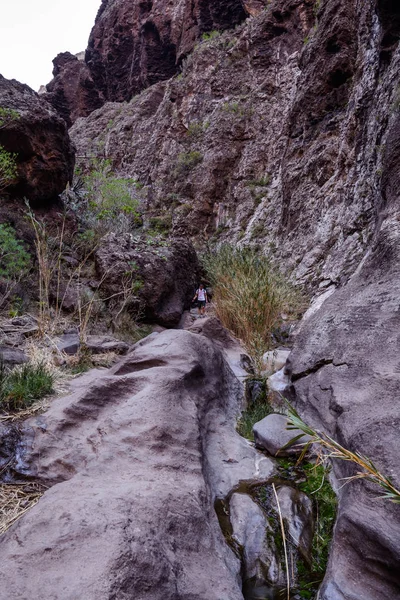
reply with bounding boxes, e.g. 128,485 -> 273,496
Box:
289,115 -> 400,600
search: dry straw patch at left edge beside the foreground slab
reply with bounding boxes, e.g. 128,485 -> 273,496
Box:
0,483 -> 46,535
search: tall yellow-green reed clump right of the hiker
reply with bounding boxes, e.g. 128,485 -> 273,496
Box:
204,245 -> 303,371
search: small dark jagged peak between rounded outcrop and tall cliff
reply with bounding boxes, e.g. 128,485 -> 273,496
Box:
41,52 -> 104,127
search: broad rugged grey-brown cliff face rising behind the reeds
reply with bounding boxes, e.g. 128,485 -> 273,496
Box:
71,0 -> 398,289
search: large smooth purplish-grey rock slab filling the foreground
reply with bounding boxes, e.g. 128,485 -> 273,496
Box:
0,330 -> 272,600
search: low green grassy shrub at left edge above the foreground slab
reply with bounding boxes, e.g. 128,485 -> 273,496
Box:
0,363 -> 54,412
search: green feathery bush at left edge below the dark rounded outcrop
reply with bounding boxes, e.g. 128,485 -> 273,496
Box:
0,223 -> 30,280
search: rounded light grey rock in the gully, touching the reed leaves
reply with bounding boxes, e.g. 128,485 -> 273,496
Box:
253,413 -> 310,456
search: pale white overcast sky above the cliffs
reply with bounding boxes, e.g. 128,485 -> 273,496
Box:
0,0 -> 101,91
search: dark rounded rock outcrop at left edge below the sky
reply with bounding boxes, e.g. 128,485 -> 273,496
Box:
0,75 -> 75,202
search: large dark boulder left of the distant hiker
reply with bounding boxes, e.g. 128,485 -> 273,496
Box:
95,234 -> 200,327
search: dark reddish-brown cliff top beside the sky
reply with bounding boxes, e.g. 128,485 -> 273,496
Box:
86,0 -> 250,101
